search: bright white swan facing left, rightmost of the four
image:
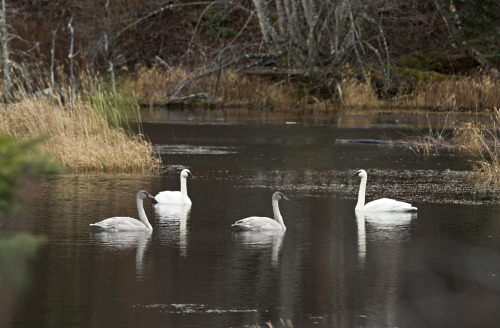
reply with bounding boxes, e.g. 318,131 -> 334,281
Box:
352,170 -> 417,212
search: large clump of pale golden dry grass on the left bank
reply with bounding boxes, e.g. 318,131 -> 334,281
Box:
0,93 -> 160,172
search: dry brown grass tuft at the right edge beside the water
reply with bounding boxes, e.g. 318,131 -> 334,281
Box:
453,109 -> 500,188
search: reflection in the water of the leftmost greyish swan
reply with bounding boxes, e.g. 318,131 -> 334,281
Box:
93,231 -> 153,276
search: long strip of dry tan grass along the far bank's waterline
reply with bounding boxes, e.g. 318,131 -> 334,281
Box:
128,65 -> 500,111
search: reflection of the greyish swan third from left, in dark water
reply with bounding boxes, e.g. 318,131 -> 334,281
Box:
233,231 -> 285,266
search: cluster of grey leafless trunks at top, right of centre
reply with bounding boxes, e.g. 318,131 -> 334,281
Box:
252,0 -> 388,77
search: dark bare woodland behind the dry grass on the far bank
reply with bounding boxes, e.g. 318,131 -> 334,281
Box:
2,0 -> 500,105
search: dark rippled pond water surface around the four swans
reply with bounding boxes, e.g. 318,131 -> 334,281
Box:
0,111 -> 500,327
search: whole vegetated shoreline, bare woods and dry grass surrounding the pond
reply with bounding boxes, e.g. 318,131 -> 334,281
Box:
0,0 -> 500,176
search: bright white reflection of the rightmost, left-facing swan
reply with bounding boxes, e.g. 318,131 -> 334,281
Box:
355,211 -> 417,264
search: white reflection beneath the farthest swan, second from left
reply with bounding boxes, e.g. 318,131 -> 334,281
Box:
154,203 -> 191,256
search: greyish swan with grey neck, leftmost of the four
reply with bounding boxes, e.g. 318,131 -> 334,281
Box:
90,190 -> 154,231
